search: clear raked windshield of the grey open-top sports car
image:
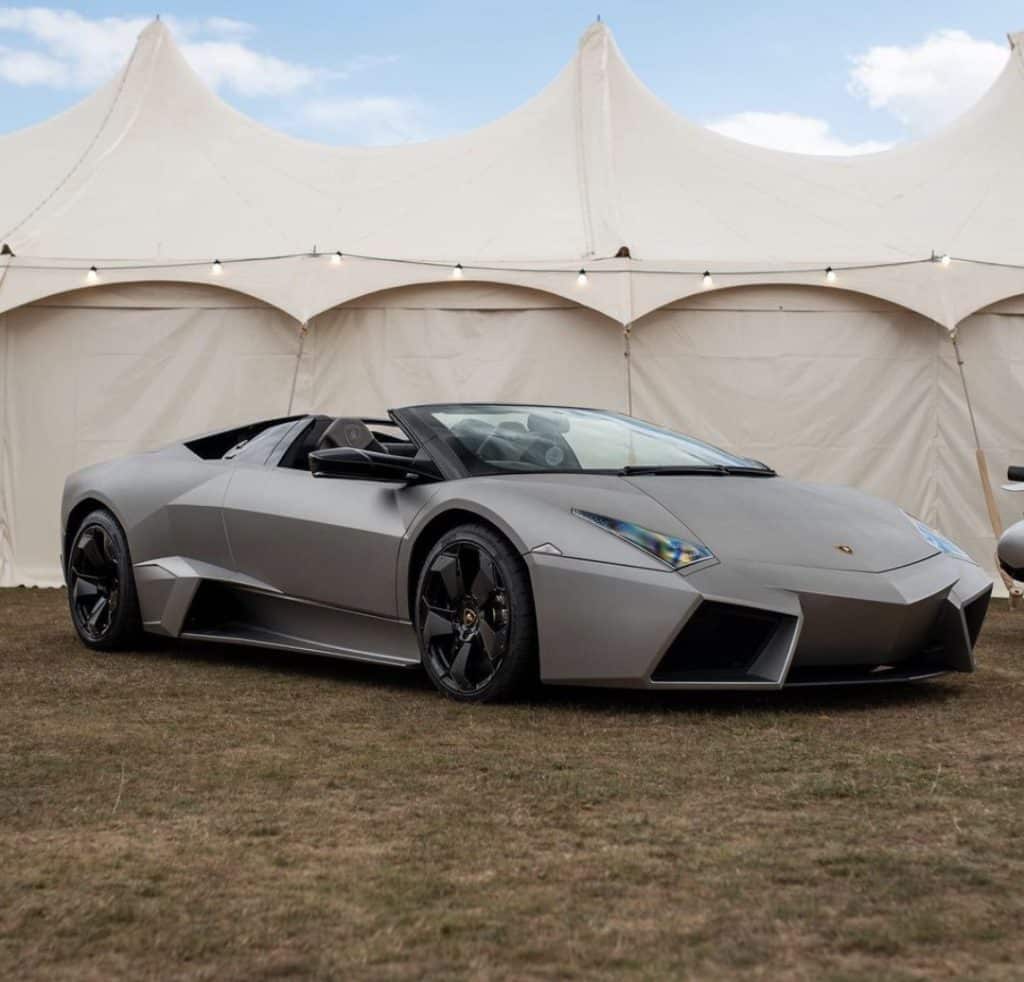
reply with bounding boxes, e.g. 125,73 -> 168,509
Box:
416,405 -> 774,475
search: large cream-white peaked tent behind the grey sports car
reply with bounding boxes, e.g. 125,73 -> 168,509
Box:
0,22 -> 1024,585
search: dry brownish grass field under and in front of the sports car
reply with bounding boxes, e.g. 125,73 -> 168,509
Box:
0,590 -> 1024,980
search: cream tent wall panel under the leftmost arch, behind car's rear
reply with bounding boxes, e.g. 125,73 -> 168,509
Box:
0,285 -> 298,586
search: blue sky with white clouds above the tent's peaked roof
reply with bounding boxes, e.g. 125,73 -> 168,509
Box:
0,0 -> 1024,153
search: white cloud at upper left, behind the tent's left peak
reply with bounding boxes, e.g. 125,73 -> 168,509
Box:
0,7 -> 395,96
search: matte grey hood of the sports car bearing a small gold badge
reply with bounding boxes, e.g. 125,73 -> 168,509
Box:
628,475 -> 936,572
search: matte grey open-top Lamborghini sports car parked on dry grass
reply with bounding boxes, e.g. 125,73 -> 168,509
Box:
61,404 -> 991,701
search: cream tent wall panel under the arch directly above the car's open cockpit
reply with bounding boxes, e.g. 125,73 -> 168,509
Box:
307,285 -> 627,414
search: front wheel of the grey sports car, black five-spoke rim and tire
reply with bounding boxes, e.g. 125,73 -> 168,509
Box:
413,524 -> 538,702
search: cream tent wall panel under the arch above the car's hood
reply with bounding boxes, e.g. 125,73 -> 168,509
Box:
632,287 -> 942,535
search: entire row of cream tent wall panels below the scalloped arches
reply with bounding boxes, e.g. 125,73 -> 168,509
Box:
0,276 -> 1024,586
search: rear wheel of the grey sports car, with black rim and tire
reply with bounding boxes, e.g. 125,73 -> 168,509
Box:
65,509 -> 142,651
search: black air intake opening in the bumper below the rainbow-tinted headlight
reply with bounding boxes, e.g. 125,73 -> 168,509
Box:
652,601 -> 781,682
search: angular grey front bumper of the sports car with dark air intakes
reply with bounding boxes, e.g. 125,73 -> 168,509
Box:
526,553 -> 992,689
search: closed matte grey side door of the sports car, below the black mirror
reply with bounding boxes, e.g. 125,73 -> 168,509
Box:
223,462 -> 416,617
